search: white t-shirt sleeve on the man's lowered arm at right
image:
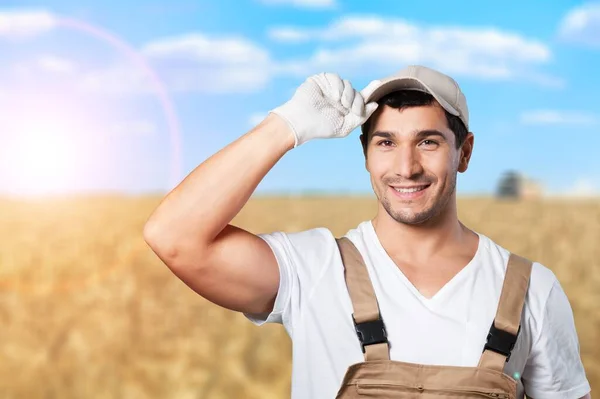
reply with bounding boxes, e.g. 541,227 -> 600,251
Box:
522,280 -> 590,399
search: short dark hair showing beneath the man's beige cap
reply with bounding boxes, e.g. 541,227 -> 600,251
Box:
360,90 -> 469,156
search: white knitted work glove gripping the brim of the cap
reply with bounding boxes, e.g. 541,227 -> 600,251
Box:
270,73 -> 380,148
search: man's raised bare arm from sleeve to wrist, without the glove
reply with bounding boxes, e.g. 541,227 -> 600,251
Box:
144,114 -> 294,313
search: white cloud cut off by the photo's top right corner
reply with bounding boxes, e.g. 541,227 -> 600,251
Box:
558,2 -> 600,47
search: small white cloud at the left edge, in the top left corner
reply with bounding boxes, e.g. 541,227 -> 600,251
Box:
0,9 -> 58,38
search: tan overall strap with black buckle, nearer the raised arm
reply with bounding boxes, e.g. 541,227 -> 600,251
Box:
336,237 -> 390,361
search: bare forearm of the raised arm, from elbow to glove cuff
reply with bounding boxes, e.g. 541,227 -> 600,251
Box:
144,114 -> 294,253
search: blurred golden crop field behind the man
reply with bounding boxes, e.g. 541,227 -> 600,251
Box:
0,197 -> 600,399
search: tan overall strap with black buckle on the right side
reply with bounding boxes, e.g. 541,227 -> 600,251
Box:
479,253 -> 533,372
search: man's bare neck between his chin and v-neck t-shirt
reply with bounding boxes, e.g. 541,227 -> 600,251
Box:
371,205 -> 473,262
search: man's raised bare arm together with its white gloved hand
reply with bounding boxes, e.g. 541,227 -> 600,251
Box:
143,74 -> 377,313
